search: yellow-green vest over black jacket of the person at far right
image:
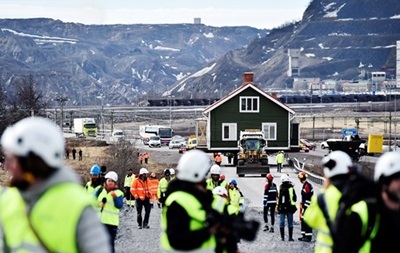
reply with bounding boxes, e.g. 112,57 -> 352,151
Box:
350,200 -> 380,253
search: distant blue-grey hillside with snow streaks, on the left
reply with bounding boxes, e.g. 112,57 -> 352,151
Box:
0,18 -> 268,106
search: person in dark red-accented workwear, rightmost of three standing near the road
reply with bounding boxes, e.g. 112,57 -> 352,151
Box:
297,171 -> 314,242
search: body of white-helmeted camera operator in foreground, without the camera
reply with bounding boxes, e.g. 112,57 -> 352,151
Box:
161,150 -> 218,253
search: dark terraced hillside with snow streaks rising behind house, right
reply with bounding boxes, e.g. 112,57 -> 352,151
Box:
173,0 -> 400,97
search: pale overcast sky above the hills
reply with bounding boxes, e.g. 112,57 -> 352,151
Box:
0,0 -> 311,29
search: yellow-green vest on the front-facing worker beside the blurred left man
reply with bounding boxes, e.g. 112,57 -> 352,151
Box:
97,188 -> 124,227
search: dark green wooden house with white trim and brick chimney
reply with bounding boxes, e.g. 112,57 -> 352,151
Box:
196,73 -> 300,153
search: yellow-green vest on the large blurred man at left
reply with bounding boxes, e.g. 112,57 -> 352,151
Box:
0,183 -> 93,253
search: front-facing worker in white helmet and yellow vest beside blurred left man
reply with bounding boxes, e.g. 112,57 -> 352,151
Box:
95,171 -> 124,252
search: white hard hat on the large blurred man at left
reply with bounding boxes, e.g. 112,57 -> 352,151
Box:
1,117 -> 65,169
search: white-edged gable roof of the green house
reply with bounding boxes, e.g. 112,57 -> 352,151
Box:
203,83 -> 295,114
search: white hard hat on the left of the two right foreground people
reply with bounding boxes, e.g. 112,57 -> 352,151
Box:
322,150 -> 353,178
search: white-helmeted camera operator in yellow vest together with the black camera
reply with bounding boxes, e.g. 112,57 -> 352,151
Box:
161,150 -> 259,253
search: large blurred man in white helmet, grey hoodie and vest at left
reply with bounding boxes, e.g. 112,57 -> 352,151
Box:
0,116 -> 111,253
